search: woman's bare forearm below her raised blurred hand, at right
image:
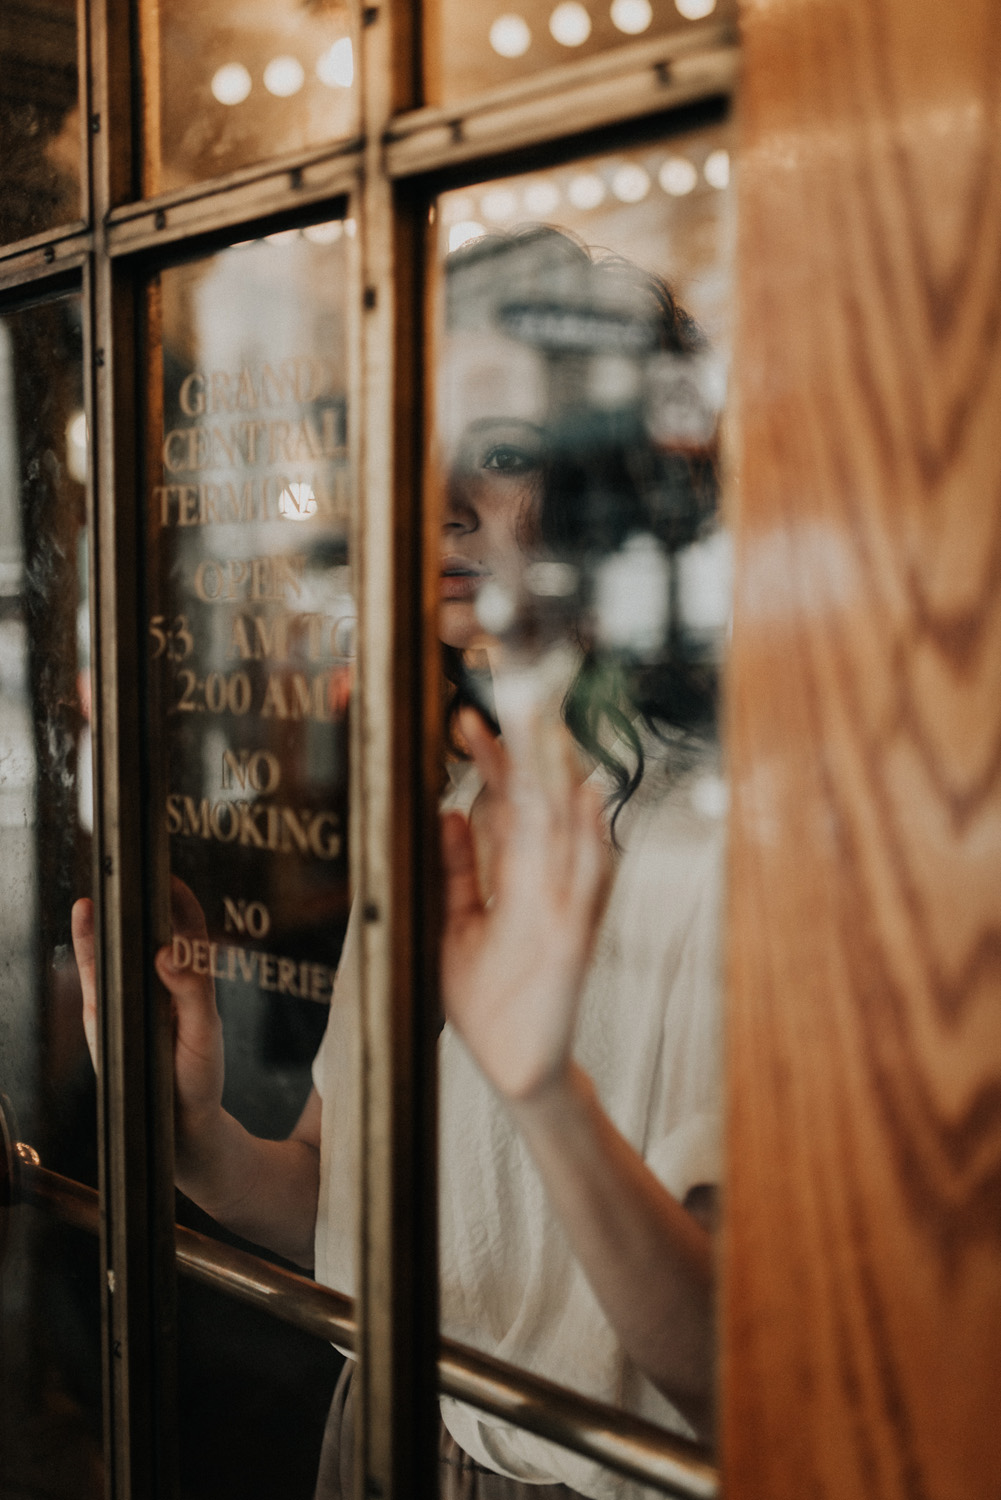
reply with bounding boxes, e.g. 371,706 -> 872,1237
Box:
509,1064 -> 714,1436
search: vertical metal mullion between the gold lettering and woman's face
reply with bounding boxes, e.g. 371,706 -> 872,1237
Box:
354,3 -> 438,1500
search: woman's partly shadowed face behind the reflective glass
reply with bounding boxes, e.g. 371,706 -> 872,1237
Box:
438,416 -> 542,651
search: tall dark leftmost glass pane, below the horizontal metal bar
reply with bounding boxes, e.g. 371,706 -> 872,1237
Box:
0,297 -> 104,1500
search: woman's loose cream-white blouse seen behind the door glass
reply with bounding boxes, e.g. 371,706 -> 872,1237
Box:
314,740 -> 725,1500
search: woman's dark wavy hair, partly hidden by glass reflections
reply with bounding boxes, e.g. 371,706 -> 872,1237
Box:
443,225 -> 719,833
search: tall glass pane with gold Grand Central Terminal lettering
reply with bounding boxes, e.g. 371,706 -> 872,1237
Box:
147,221 -> 356,1500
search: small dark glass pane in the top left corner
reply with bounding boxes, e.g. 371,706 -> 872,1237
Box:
0,0 -> 84,245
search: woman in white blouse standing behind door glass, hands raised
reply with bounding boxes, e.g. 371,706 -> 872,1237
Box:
74,230 -> 720,1500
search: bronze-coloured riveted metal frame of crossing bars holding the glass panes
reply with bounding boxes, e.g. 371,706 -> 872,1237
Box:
0,0 -> 737,1500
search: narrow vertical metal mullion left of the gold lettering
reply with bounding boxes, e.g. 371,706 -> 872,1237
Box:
86,0 -> 177,1500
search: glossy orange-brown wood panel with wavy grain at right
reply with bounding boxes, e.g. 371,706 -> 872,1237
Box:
723,0 -> 1001,1500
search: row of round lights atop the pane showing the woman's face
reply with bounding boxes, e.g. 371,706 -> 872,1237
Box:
447,147 -> 729,251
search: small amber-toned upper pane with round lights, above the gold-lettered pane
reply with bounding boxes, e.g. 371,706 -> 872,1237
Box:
144,0 -> 357,192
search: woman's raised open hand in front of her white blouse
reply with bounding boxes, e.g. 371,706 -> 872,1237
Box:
441,710 -> 608,1101
